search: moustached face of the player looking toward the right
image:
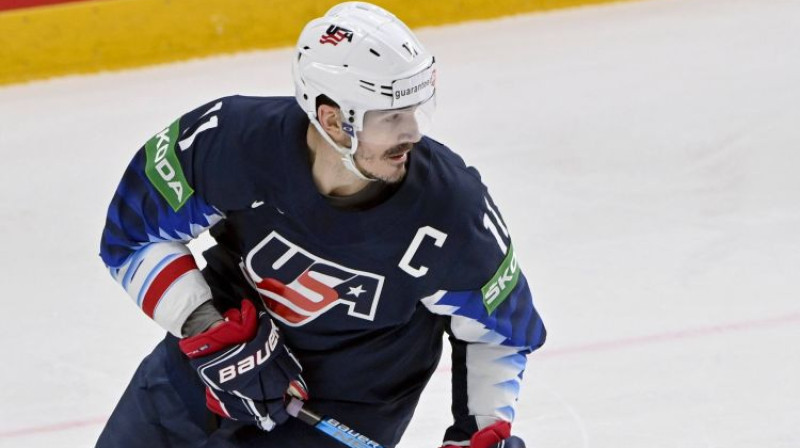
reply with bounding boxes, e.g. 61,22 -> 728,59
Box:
355,100 -> 433,183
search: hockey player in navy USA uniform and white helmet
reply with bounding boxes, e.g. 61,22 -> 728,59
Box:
97,2 -> 545,448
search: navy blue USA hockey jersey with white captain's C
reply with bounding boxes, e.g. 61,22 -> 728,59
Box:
101,97 -> 545,445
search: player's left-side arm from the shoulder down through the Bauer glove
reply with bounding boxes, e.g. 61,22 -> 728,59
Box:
101,99 -> 307,430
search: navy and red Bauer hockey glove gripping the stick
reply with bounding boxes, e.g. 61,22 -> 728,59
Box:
180,300 -> 308,431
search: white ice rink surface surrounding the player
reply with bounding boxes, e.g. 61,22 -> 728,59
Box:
0,0 -> 800,448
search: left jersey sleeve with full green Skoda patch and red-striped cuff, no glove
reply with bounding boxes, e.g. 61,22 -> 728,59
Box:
100,100 -> 230,337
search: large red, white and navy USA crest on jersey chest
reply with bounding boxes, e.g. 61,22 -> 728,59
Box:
245,231 -> 384,326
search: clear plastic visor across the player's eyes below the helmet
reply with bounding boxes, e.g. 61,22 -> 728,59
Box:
357,94 -> 436,146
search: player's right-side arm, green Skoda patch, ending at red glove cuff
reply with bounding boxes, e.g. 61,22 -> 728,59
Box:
422,194 -> 546,448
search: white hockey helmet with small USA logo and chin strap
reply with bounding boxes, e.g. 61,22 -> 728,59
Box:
292,2 -> 436,179
